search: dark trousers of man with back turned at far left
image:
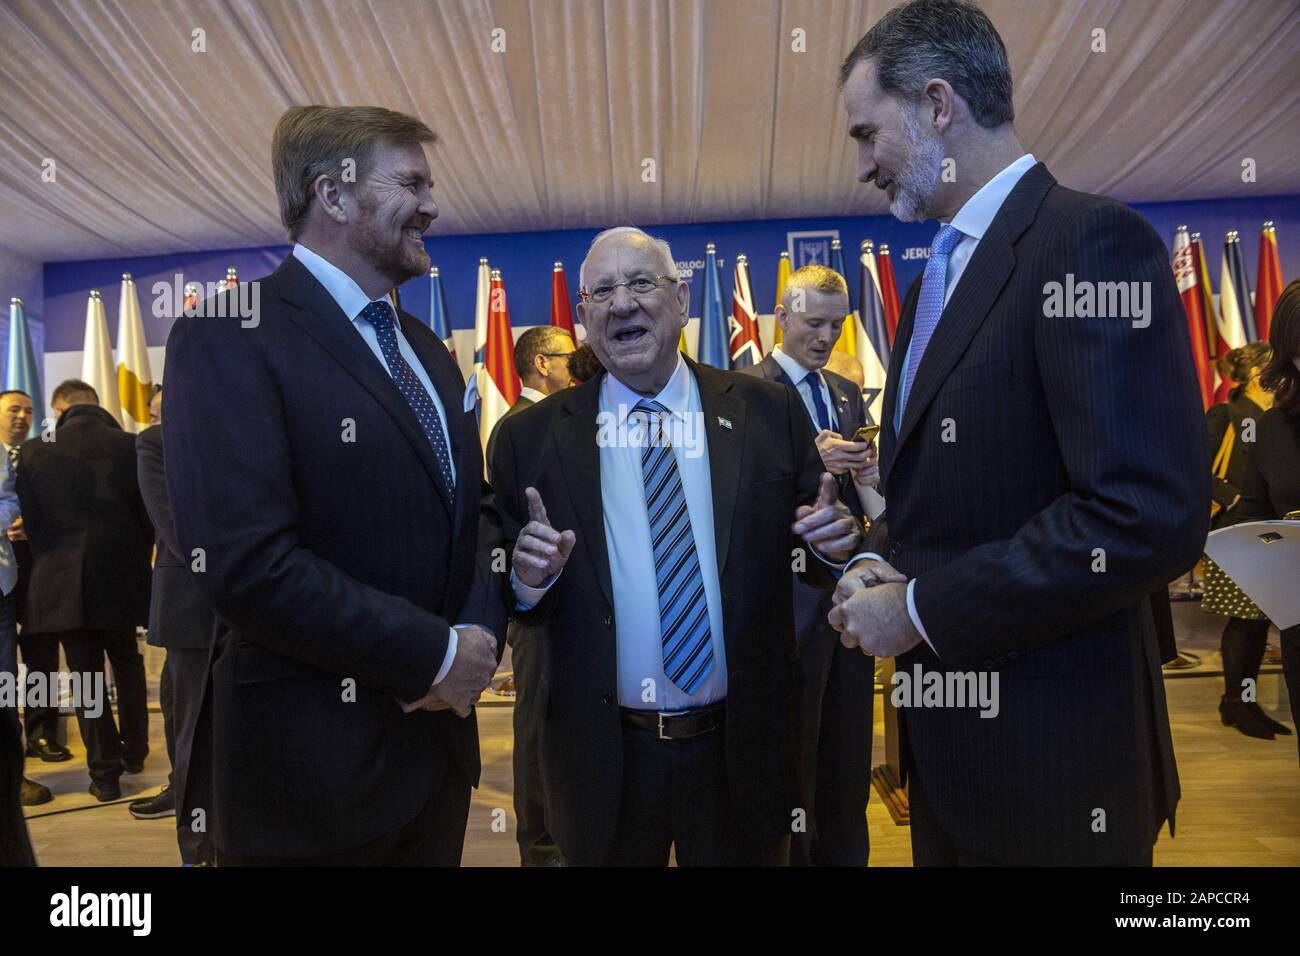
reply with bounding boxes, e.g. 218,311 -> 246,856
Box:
59,627 -> 150,784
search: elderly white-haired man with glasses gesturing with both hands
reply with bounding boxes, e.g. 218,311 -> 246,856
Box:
493,226 -> 861,865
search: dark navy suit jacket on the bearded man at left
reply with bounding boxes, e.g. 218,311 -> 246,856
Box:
163,256 -> 506,857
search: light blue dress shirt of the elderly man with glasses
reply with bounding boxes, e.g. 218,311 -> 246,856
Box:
511,356 -> 727,710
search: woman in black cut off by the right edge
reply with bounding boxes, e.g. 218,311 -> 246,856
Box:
1236,280 -> 1300,764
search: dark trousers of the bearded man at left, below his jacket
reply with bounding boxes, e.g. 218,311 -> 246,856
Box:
217,763 -> 469,866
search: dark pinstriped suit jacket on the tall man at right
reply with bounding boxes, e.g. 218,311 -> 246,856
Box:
876,164 -> 1209,864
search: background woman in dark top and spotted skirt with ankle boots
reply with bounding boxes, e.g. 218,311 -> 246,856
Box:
1201,342 -> 1291,740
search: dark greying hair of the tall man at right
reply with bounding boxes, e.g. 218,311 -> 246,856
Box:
840,0 -> 1015,129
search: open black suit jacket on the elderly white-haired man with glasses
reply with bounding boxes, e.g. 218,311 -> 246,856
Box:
493,359 -> 832,864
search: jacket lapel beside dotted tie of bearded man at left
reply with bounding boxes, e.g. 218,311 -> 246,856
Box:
276,256 -> 459,515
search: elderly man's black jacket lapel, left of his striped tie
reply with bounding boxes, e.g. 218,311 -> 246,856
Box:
553,375 -> 614,607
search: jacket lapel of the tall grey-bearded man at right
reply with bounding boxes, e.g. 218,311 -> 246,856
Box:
891,163 -> 1056,460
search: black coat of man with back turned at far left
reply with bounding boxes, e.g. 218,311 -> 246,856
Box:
17,405 -> 153,635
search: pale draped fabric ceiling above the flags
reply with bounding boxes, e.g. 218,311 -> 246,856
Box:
0,0 -> 1300,261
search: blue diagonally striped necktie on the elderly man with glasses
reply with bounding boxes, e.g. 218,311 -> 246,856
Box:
633,402 -> 714,693
